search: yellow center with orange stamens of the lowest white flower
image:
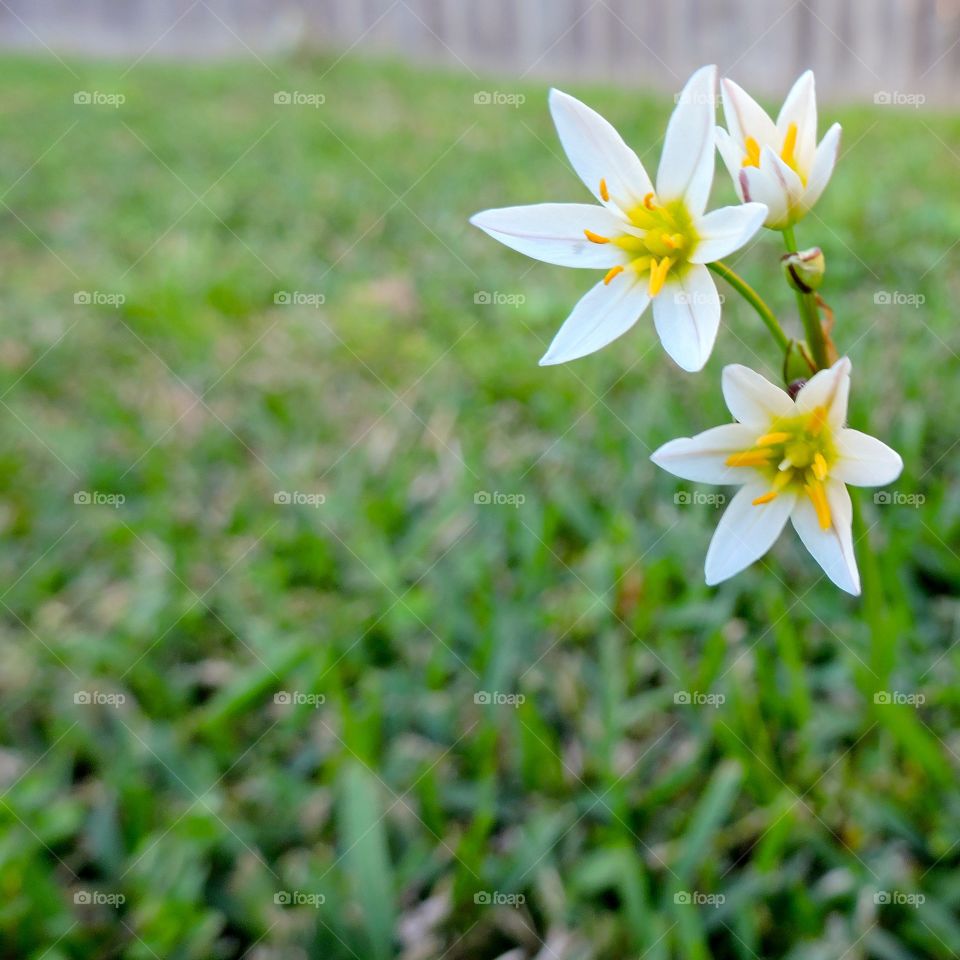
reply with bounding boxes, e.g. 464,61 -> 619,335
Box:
726,407 -> 837,530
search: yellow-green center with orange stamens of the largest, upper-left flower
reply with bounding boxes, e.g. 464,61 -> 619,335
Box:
583,188 -> 700,297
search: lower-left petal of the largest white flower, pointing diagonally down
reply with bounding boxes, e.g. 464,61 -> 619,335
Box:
540,273 -> 650,367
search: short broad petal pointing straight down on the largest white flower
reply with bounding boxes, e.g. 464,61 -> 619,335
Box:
653,263 -> 720,373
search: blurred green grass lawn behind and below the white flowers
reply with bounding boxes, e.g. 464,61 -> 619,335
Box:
0,52 -> 960,960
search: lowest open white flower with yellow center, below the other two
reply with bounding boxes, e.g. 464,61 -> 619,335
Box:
650,357 -> 903,594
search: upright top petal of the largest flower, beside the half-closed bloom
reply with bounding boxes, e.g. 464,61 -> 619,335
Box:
657,66 -> 717,217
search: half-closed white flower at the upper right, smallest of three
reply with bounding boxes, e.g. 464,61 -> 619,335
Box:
717,70 -> 840,230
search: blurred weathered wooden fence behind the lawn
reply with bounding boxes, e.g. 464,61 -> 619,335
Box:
0,0 -> 960,105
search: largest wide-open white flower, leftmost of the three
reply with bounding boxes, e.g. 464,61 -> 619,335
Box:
470,67 -> 767,371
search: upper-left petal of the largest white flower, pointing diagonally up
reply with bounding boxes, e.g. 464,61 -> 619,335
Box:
550,90 -> 653,210
